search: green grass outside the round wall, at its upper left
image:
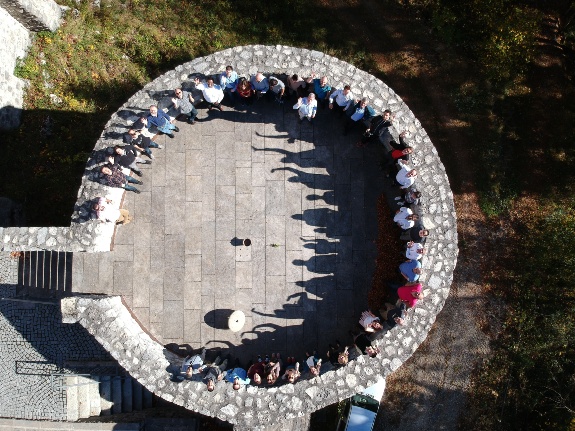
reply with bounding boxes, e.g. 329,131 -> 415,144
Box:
0,0 -> 378,226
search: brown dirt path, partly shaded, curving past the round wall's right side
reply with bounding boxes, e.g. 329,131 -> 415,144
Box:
320,0 -> 500,431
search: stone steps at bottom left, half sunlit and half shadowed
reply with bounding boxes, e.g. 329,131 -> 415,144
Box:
62,375 -> 154,422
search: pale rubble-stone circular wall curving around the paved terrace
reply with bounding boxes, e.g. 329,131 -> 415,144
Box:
66,45 -> 458,429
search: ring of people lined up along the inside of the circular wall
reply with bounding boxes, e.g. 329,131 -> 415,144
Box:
93,66 -> 429,391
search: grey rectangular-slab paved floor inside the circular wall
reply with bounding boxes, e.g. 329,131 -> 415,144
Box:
73,101 -> 383,359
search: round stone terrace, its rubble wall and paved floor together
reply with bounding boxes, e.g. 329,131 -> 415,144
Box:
0,45 -> 458,429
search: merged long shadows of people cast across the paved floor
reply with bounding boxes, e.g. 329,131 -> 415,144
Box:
217,107 -> 388,359
